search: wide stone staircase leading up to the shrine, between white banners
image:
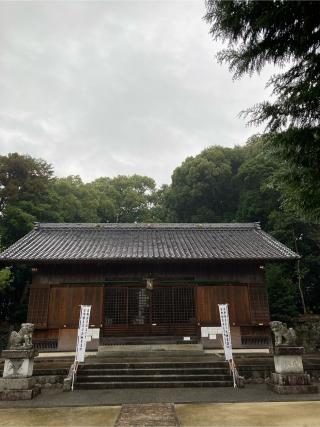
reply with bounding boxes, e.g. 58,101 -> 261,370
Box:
74,358 -> 233,390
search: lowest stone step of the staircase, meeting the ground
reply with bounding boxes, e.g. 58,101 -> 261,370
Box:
74,380 -> 233,390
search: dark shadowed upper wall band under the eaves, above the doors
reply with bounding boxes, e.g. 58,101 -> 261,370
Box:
32,261 -> 264,286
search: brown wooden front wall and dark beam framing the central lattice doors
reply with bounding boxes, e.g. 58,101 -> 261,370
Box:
28,262 -> 269,329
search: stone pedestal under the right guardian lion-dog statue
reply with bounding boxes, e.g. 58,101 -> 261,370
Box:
267,346 -> 318,394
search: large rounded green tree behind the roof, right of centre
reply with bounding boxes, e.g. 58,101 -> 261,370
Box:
165,146 -> 243,222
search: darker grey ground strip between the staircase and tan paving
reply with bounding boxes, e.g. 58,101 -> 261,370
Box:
0,384 -> 320,408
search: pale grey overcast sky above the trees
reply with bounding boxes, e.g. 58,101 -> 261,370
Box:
0,0 -> 271,185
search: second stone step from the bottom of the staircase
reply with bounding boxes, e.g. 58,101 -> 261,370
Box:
77,374 -> 230,384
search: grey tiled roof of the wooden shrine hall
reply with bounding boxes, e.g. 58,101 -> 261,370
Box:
0,223 -> 298,262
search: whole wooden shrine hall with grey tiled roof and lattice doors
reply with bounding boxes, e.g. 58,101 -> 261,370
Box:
0,223 -> 298,351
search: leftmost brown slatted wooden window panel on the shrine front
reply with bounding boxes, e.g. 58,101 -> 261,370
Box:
28,288 -> 50,328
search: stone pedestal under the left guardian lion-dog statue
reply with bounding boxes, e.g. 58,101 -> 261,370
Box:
0,349 -> 41,400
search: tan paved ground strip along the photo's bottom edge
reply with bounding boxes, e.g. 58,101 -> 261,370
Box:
0,402 -> 320,427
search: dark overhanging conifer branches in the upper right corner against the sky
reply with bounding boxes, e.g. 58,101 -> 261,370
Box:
205,0 -> 320,220
